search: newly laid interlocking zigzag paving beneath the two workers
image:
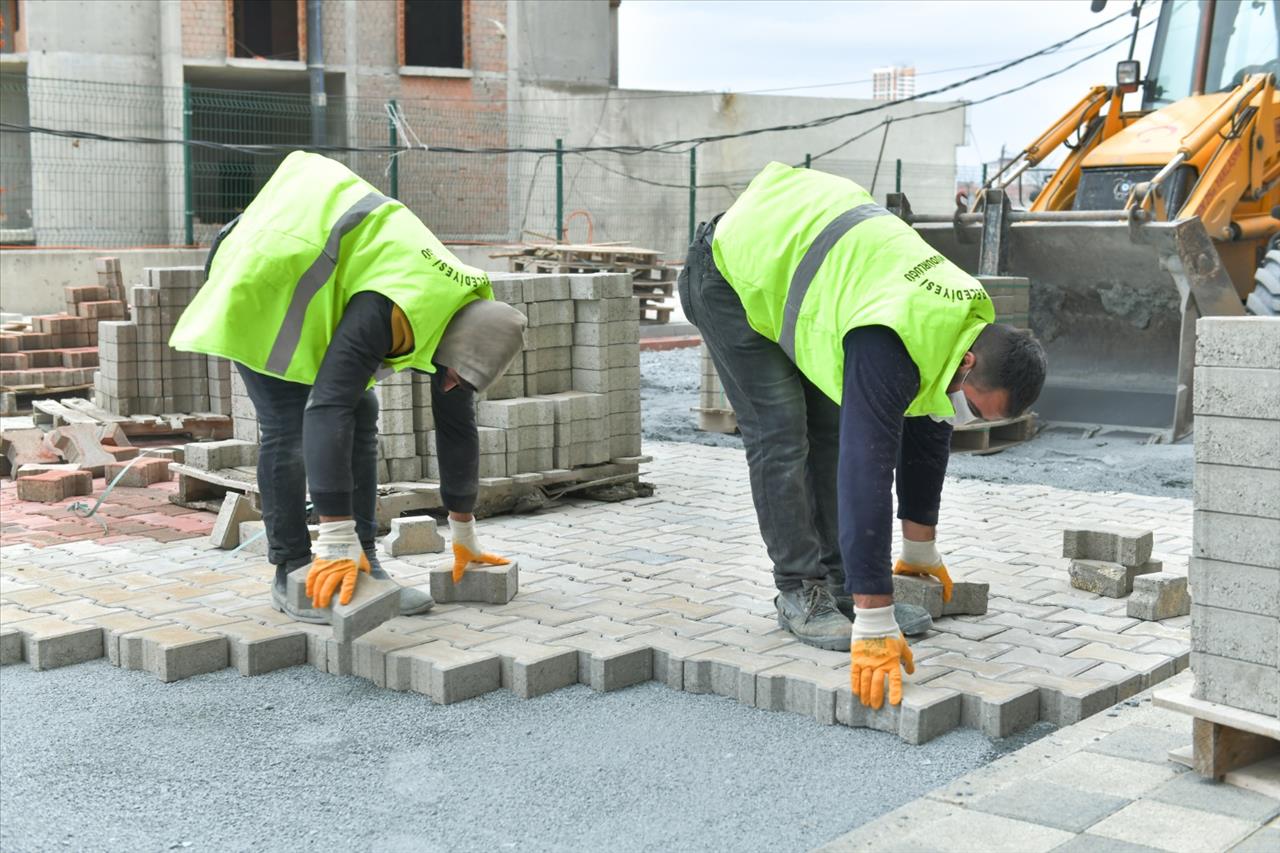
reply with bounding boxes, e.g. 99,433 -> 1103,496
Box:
0,443 -> 1190,743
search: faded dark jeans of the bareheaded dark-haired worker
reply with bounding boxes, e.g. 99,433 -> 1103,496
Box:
677,218 -> 845,596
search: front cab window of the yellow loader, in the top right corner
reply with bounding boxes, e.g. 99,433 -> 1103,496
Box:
1204,0 -> 1280,92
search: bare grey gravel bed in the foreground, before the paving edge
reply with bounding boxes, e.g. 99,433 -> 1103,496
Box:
0,661 -> 1047,853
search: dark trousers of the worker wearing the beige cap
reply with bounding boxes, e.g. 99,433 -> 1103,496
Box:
236,364 -> 378,571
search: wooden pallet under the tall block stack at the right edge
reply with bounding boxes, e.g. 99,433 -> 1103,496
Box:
1152,683 -> 1280,778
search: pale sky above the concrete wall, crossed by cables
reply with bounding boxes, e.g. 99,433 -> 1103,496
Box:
618,0 -> 1158,164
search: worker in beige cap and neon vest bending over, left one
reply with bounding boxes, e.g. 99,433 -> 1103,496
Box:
169,152 -> 525,622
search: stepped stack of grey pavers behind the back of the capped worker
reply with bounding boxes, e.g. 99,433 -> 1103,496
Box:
95,266 -> 232,415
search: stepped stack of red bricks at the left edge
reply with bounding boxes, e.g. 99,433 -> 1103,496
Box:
0,257 -> 128,414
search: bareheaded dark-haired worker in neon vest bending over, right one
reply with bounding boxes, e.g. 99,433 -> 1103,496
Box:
678,163 -> 1044,707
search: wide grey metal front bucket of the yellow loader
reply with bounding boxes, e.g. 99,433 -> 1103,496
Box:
915,214 -> 1243,441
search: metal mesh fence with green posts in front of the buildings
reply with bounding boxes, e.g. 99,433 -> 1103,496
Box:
0,73 -> 988,257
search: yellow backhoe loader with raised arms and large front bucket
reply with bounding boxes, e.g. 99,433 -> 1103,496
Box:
888,0 -> 1280,441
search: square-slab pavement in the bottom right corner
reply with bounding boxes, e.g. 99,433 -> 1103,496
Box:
819,672 -> 1280,853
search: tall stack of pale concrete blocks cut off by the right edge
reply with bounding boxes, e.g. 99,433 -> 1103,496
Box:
1190,318 -> 1280,717
